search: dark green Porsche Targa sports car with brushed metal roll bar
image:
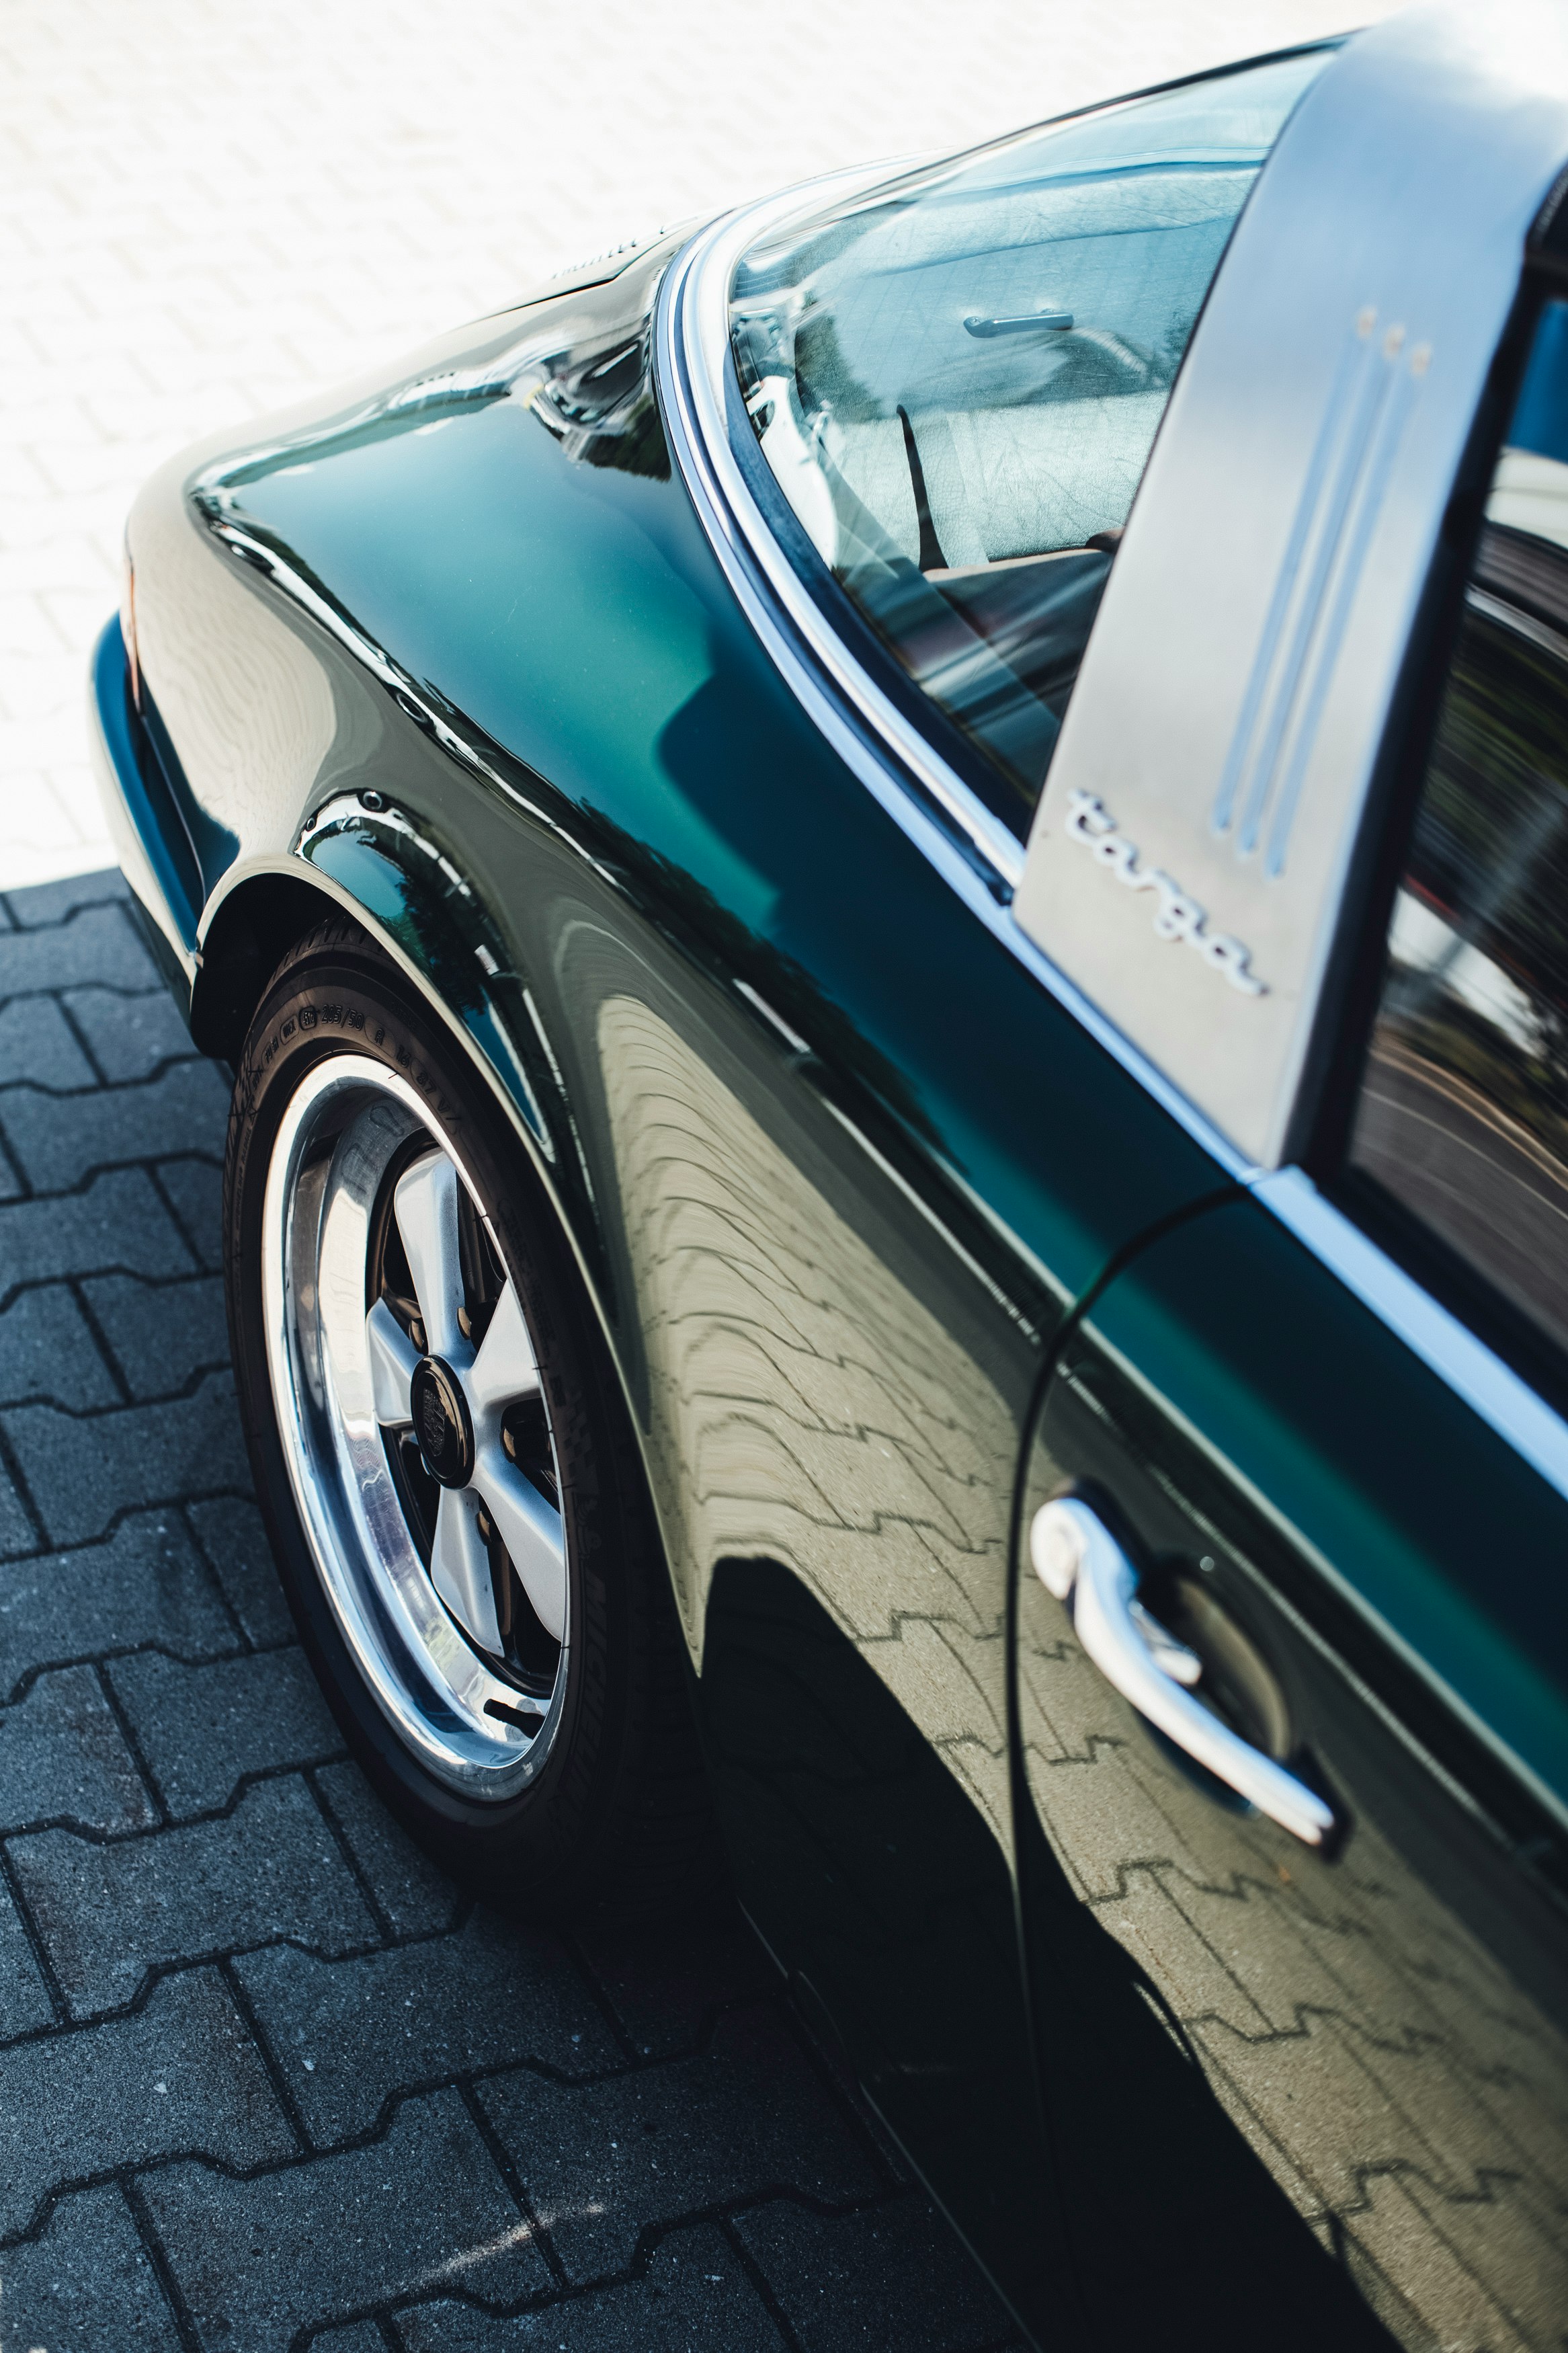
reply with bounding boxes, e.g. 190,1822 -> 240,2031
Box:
91,0 -> 1568,2353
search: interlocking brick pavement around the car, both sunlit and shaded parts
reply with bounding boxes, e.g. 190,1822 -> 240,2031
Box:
0,0 -> 1401,2353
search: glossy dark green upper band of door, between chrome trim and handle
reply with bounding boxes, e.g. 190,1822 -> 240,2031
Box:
1091,1200 -> 1568,1805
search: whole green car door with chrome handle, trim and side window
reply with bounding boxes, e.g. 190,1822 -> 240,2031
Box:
1016,50 -> 1568,2348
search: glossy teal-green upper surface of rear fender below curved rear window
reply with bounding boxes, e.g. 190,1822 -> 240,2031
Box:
190,270 -> 1218,1327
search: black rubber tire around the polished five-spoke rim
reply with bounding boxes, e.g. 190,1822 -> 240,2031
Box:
223,918 -> 717,1920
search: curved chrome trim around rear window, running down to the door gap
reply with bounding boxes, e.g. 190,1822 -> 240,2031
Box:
653,176 -> 1255,1181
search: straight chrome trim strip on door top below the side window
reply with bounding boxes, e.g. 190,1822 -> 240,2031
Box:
1248,1167 -> 1568,1497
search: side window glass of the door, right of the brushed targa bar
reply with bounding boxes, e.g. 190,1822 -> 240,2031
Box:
1350,301 -> 1568,1353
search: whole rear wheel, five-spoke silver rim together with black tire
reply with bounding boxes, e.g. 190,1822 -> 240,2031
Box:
223,918 -> 712,1915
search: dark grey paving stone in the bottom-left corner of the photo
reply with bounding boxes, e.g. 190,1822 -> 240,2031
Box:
0,2184 -> 179,2353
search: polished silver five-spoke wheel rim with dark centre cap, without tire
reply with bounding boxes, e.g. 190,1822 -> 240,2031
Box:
261,1054 -> 571,1800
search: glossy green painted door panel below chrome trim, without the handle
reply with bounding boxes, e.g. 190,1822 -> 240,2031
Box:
1016,1200 -> 1568,2353
